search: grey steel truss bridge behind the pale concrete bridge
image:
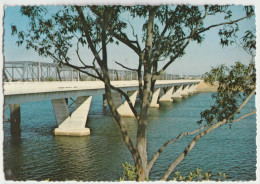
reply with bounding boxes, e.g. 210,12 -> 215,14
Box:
4,61 -> 180,81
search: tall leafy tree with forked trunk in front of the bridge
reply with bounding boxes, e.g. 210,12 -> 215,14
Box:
12,5 -> 255,181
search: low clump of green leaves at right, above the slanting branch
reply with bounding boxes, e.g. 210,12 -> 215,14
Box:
198,62 -> 256,124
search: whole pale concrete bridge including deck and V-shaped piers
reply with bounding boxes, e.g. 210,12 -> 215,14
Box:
4,80 -> 200,136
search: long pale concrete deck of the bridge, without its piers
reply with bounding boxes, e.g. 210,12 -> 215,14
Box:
4,80 -> 200,104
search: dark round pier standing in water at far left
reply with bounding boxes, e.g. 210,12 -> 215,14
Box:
10,104 -> 21,135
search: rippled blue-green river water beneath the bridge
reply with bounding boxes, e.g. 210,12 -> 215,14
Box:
4,93 -> 256,181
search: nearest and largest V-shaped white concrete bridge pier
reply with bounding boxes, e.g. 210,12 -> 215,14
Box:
52,96 -> 92,136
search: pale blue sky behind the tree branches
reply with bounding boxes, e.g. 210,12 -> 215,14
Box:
4,6 -> 255,75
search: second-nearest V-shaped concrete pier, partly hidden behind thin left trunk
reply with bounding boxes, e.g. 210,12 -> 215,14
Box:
112,91 -> 138,117
